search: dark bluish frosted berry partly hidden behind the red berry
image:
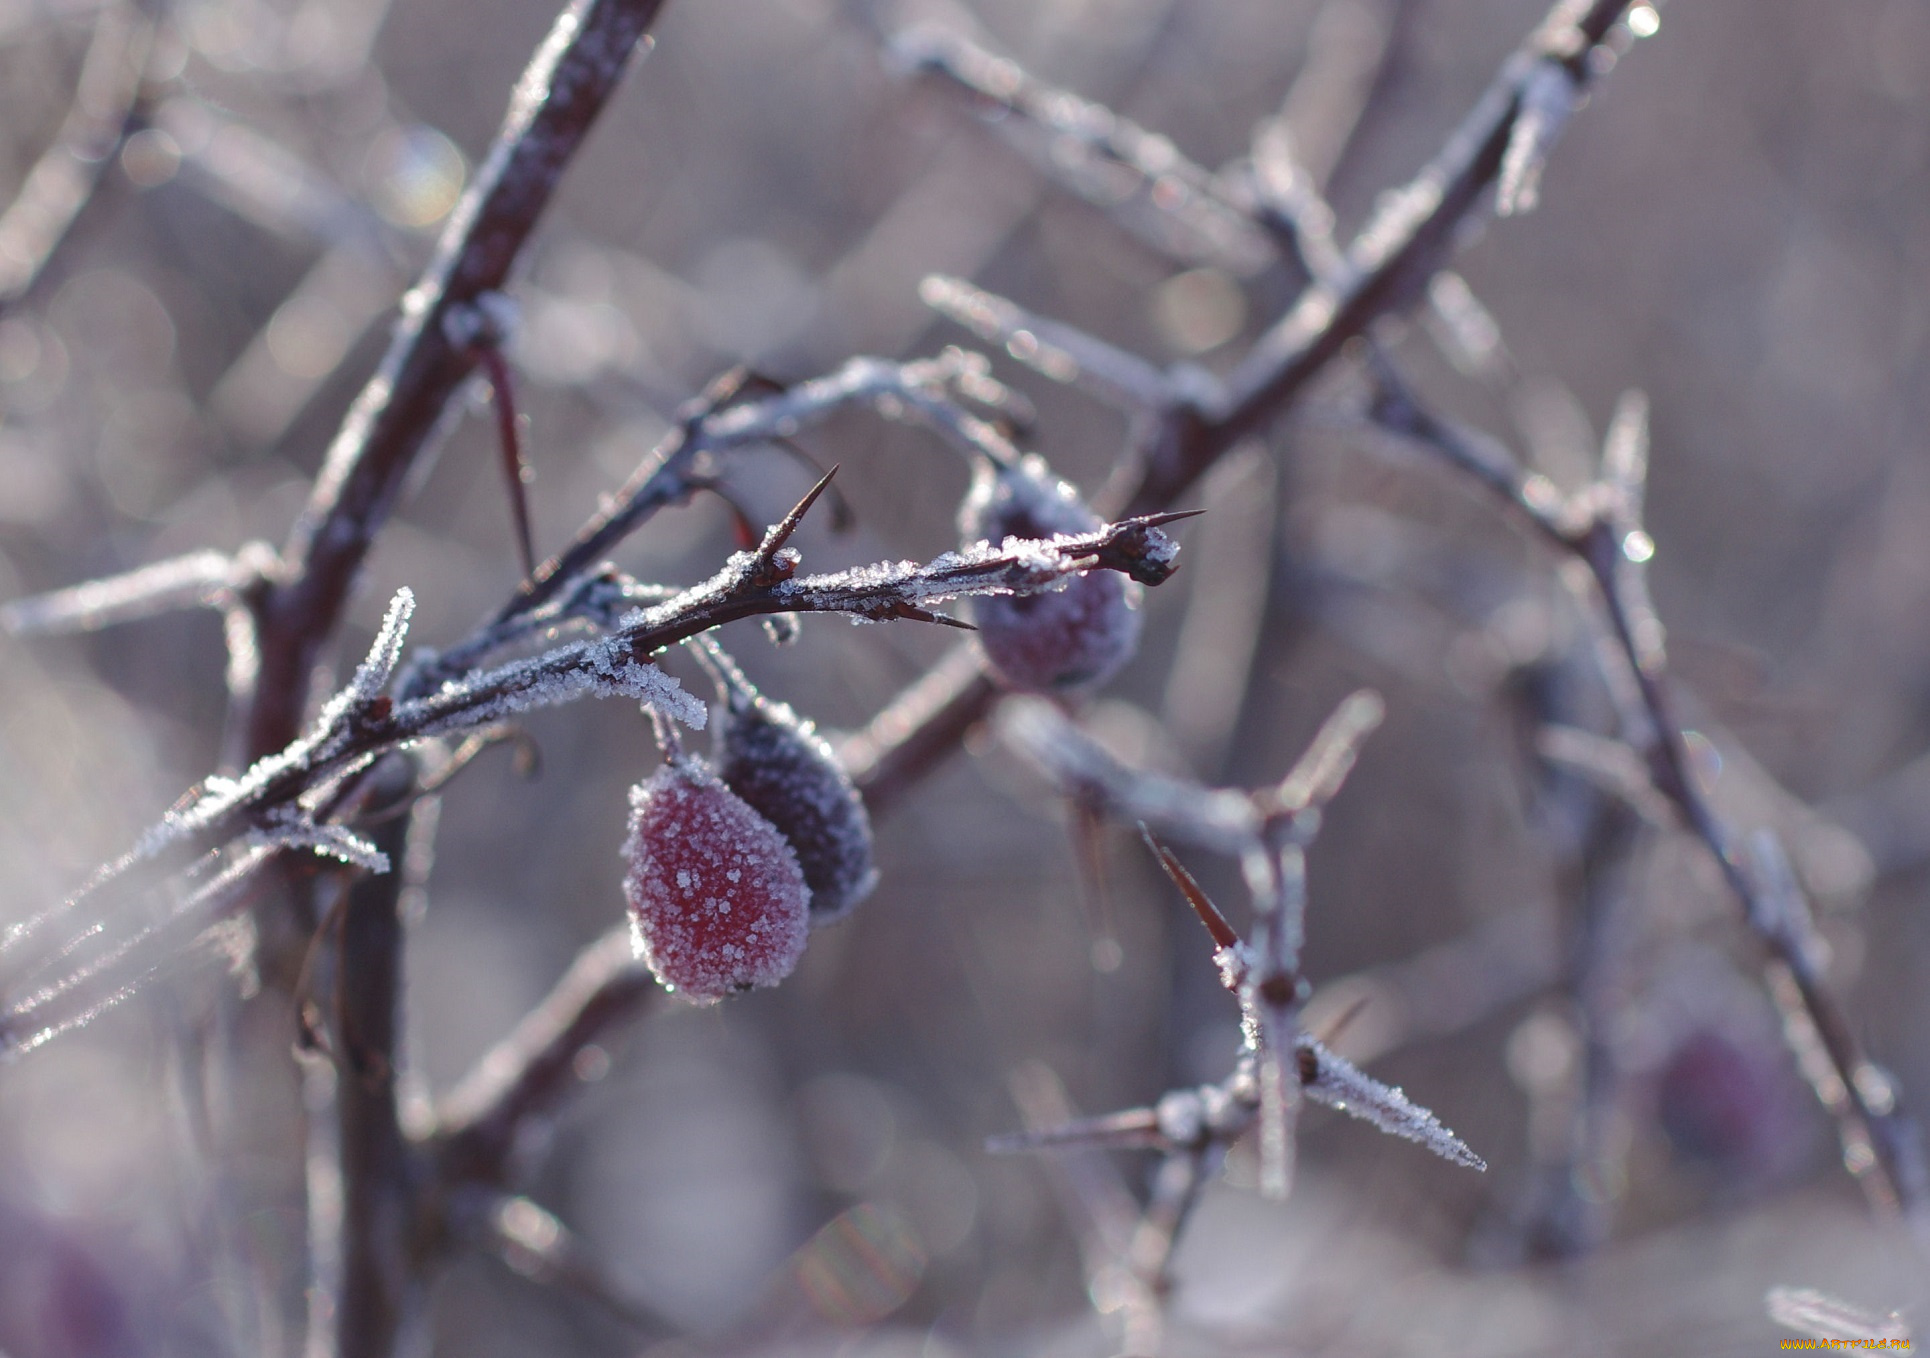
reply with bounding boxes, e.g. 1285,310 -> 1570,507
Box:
716,685 -> 878,924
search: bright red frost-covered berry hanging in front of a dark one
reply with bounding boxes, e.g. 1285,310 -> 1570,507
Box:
623,758 -> 811,1003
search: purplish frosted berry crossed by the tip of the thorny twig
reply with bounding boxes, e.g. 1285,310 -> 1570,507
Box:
959,453 -> 1139,693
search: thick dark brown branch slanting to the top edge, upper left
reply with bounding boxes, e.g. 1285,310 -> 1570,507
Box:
243,0 -> 662,762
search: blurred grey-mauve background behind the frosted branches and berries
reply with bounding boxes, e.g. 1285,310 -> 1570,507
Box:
0,0 -> 1930,1358
